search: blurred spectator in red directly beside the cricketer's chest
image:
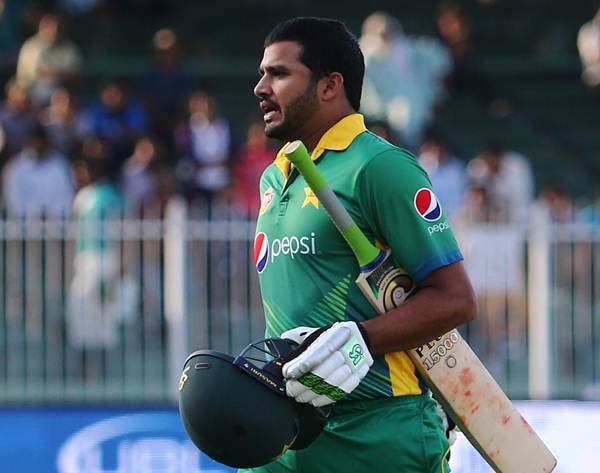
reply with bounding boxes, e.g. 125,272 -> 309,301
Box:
233,120 -> 277,218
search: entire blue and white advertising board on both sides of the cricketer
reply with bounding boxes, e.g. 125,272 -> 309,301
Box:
0,401 -> 600,473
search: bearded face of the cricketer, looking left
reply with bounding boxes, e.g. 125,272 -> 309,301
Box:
254,41 -> 319,141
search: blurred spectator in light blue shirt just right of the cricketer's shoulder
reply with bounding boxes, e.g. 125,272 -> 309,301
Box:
419,132 -> 467,218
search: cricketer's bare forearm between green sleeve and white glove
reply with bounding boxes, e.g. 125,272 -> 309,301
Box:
362,262 -> 476,355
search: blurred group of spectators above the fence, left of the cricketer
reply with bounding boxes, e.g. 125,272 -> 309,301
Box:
0,8 -> 275,216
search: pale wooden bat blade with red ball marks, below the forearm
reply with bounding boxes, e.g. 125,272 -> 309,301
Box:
408,330 -> 557,473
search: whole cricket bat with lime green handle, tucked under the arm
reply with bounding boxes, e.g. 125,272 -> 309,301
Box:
284,141 -> 556,473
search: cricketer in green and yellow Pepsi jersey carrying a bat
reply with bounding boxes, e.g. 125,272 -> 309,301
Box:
246,18 -> 475,473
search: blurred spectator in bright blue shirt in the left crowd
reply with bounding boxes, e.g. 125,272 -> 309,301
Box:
82,81 -> 148,161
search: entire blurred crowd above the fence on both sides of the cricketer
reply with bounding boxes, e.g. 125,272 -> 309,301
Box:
0,2 -> 600,227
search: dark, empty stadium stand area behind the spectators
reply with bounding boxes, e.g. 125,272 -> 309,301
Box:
2,0 -> 600,196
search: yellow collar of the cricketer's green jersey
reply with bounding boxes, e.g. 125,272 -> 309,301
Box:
274,113 -> 367,180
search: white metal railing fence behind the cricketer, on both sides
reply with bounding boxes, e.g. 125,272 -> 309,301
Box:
0,200 -> 600,403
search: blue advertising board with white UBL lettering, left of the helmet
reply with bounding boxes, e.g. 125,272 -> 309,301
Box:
0,408 -> 235,473
